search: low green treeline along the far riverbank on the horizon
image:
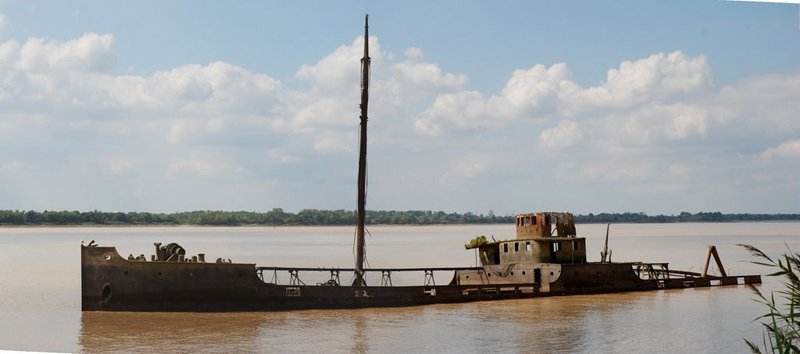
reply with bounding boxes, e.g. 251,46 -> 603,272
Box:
0,208 -> 800,225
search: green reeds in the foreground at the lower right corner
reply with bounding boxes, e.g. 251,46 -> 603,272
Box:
740,245 -> 800,353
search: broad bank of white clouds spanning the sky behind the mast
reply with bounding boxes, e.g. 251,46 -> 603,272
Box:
0,28 -> 800,216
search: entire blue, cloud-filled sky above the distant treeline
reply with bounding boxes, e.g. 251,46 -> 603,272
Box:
0,0 -> 800,215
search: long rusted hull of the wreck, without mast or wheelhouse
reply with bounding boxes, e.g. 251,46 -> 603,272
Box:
81,246 -> 760,312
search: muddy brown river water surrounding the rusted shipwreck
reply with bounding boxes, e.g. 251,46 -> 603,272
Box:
0,222 -> 800,353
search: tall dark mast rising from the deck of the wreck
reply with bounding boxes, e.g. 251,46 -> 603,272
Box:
353,15 -> 370,286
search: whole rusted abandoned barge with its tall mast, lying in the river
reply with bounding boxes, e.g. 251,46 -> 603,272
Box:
81,15 -> 761,311
